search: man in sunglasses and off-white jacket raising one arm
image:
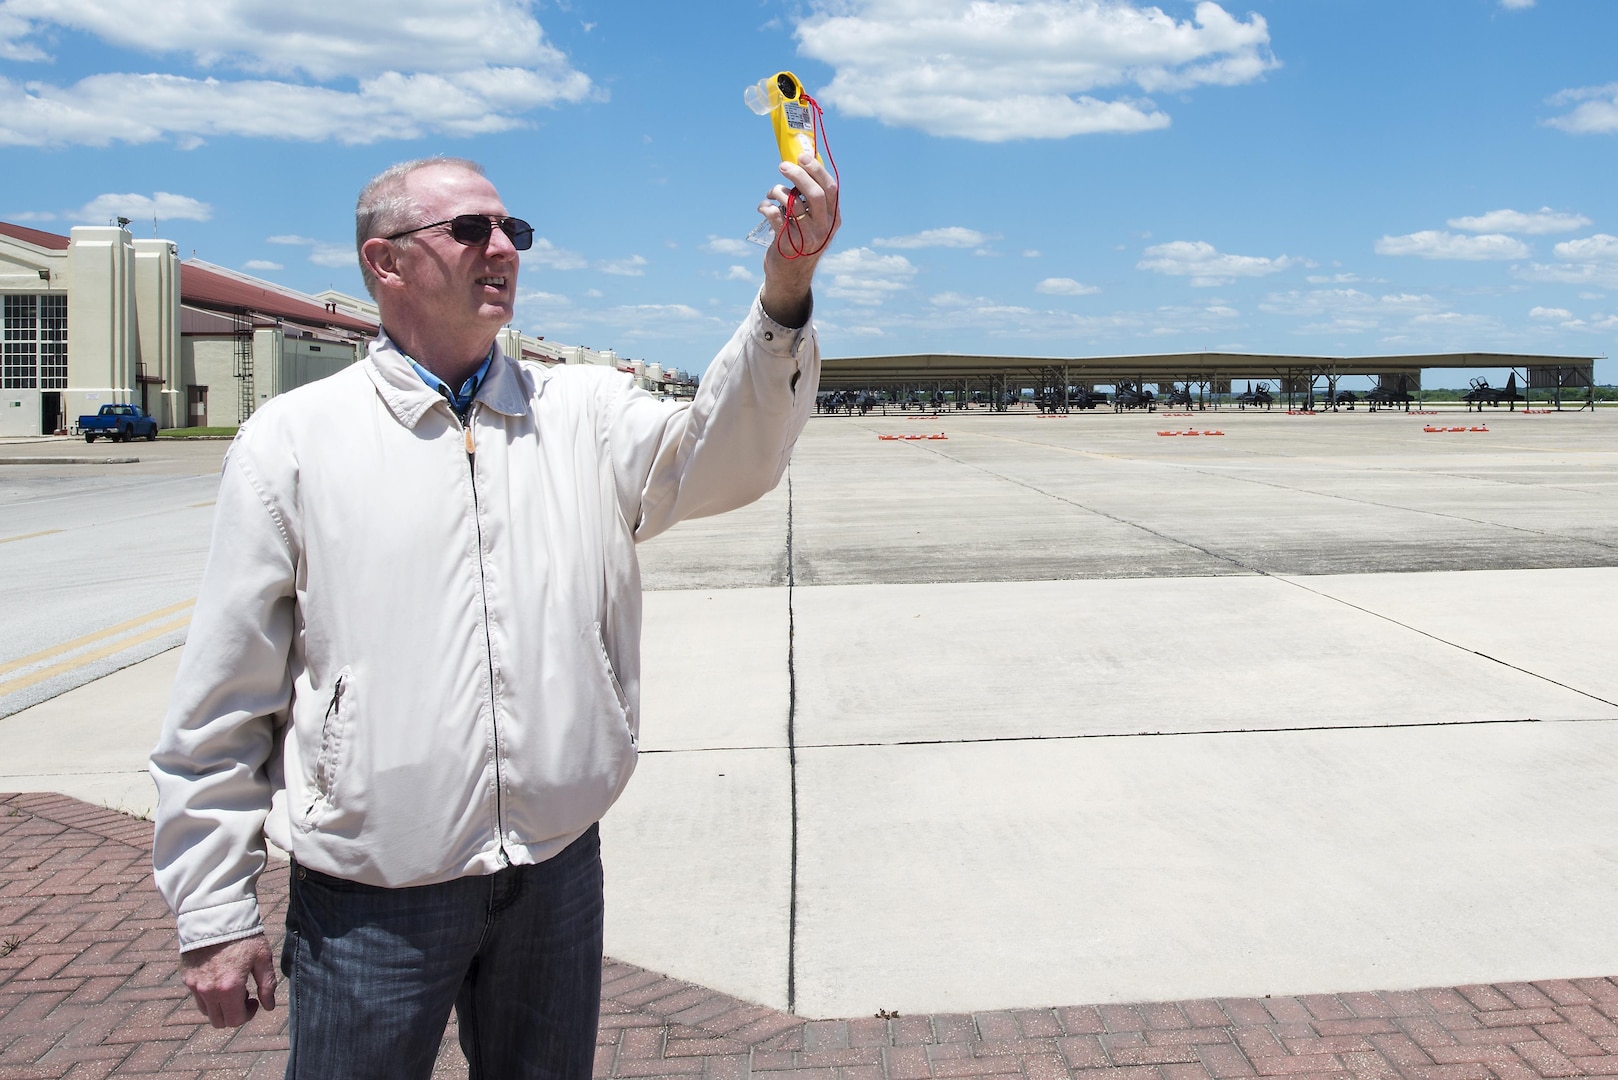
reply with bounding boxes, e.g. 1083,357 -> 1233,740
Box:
152,155 -> 838,1078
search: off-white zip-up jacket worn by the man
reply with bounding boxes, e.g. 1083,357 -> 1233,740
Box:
152,301 -> 820,949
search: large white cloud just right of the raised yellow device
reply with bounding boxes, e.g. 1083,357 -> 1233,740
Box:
796,0 -> 1277,142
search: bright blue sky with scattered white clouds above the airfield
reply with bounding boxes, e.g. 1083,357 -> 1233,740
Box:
0,0 -> 1618,382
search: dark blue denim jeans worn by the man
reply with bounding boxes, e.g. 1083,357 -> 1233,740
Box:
282,826 -> 602,1080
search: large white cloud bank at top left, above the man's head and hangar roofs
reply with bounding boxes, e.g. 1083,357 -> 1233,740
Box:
0,0 -> 597,147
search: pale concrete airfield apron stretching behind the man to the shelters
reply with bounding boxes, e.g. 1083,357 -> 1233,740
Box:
0,411 -> 1618,1015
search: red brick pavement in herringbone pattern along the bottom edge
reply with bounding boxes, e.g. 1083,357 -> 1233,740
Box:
0,793 -> 1618,1080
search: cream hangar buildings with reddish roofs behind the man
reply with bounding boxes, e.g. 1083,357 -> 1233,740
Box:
0,222 -> 693,436
